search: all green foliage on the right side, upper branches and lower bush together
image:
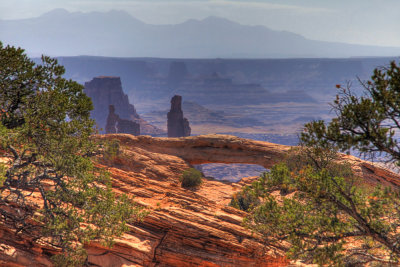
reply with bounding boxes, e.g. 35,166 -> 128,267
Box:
232,62 -> 400,266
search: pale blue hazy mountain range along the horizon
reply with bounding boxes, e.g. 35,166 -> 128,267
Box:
0,9 -> 400,58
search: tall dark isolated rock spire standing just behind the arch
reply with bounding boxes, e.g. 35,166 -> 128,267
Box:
167,95 -> 191,137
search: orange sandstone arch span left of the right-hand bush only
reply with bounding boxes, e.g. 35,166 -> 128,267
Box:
105,135 -> 290,168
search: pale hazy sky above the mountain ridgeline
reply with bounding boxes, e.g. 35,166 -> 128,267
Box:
0,0 -> 400,47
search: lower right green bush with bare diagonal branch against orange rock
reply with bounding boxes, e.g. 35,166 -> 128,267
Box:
236,148 -> 400,266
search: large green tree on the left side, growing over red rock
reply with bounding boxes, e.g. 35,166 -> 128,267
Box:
0,43 -> 146,266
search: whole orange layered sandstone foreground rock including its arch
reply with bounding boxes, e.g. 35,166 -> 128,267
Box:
0,134 -> 400,266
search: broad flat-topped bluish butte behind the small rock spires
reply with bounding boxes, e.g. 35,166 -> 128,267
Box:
85,76 -> 164,135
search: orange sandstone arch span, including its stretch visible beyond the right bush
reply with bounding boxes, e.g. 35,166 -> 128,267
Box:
97,134 -> 400,186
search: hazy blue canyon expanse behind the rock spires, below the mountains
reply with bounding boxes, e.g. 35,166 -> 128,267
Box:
51,56 -> 397,138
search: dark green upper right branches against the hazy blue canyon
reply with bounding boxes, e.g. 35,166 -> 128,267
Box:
301,61 -> 400,162
